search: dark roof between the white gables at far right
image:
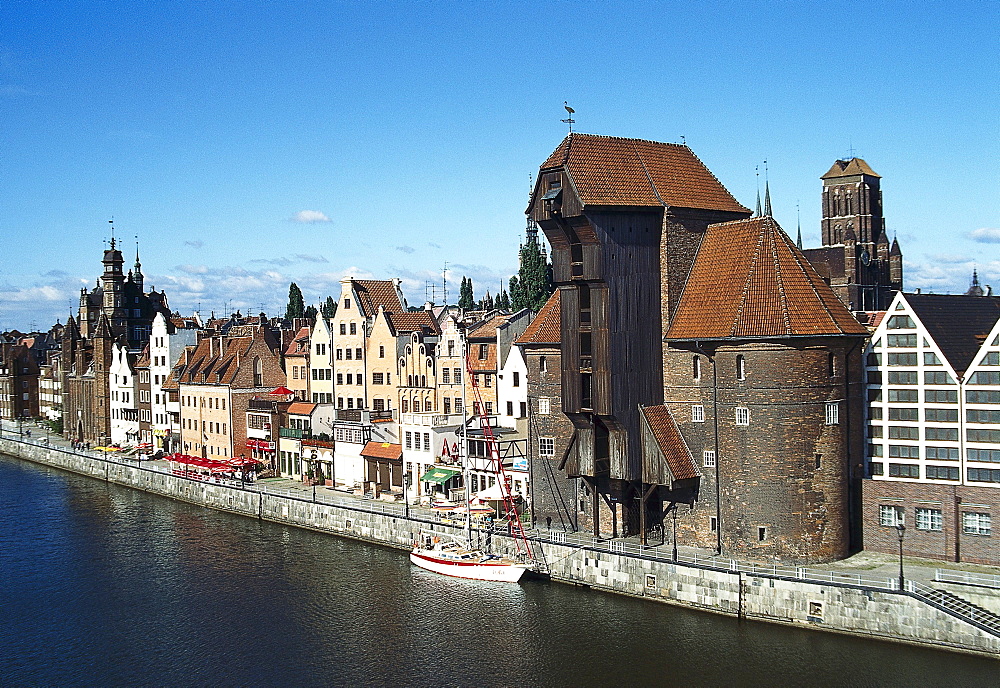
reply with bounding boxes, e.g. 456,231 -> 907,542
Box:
904,294 -> 1000,375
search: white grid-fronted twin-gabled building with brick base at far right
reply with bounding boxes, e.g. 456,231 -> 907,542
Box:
864,293 -> 1000,565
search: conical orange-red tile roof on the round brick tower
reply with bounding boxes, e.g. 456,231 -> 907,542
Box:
666,217 -> 868,339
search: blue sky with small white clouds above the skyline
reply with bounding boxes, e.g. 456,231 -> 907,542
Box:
0,1 -> 1000,330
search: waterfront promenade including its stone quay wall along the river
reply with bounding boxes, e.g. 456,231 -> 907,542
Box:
2,420 -> 1000,657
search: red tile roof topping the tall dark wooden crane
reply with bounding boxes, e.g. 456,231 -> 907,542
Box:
541,134 -> 750,213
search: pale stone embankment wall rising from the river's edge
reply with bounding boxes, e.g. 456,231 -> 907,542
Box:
7,439 -> 1000,658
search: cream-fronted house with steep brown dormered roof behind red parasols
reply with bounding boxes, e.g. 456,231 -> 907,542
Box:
171,325 -> 285,462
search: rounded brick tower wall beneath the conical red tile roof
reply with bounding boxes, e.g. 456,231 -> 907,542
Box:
664,340 -> 863,563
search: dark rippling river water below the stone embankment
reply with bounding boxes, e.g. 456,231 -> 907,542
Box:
0,456 -> 1000,688
